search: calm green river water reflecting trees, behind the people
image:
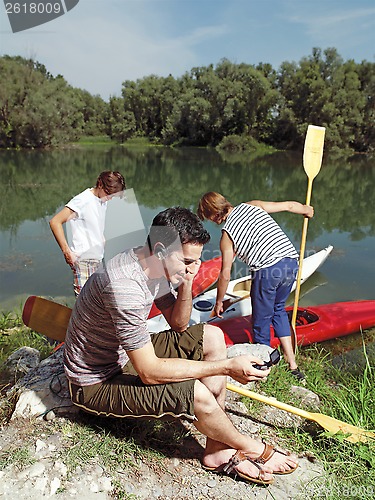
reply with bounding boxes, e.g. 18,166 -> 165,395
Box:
0,146 -> 375,312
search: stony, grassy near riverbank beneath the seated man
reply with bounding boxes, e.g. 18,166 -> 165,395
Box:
0,315 -> 375,500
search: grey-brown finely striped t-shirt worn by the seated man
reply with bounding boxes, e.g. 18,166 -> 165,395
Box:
64,250 -> 175,386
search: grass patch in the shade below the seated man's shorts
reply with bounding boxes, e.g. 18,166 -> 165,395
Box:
50,414 -> 186,500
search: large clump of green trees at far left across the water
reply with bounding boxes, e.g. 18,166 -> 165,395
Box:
0,56 -> 108,148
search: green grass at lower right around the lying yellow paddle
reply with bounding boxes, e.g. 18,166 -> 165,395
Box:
244,340 -> 375,500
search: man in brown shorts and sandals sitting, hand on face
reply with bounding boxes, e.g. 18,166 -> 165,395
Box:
64,207 -> 297,484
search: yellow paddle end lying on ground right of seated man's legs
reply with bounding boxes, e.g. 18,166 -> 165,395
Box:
227,384 -> 375,443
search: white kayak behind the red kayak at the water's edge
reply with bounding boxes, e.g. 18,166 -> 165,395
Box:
147,245 -> 333,332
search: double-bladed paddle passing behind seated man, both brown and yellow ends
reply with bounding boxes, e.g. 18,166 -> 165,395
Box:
22,295 -> 375,443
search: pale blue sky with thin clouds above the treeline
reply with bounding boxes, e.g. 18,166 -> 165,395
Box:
0,0 -> 375,100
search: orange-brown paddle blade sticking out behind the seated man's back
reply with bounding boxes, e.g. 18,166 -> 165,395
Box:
22,295 -> 72,342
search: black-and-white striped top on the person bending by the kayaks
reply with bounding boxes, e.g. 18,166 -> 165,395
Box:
222,203 -> 298,271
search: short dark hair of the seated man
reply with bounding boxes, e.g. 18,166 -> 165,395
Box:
147,207 -> 210,253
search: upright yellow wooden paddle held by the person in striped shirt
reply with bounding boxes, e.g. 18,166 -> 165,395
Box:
291,125 -> 326,352
